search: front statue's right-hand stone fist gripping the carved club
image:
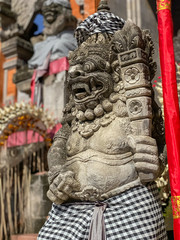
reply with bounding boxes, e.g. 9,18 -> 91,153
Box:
128,135 -> 160,183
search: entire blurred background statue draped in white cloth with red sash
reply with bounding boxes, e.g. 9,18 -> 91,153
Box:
29,0 -> 76,120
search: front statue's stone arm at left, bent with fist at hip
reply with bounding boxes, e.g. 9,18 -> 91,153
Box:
47,124 -> 79,204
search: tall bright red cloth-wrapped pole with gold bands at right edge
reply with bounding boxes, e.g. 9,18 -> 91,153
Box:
157,0 -> 180,240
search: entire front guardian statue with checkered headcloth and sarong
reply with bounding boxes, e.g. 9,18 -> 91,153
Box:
38,1 -> 167,240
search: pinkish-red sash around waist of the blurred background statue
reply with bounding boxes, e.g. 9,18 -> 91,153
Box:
31,57 -> 69,103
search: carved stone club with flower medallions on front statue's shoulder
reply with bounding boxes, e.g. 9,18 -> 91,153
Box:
110,21 -> 156,136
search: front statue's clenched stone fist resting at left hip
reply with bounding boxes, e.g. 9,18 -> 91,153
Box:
47,171 -> 79,204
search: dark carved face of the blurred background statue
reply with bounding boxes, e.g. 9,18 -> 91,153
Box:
42,3 -> 63,24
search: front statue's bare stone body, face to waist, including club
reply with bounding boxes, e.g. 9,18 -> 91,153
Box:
47,19 -> 165,204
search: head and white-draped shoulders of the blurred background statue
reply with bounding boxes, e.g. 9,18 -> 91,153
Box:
29,0 -> 76,68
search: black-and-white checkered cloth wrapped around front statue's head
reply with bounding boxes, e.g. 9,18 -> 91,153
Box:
75,12 -> 125,45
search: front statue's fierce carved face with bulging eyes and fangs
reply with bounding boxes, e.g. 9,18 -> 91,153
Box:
68,46 -> 113,104
